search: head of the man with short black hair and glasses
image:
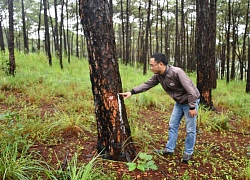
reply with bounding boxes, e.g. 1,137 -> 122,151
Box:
149,53 -> 168,74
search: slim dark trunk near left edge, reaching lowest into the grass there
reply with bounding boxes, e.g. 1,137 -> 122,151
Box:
8,0 -> 16,76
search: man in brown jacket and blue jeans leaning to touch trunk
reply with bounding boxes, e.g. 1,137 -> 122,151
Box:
120,53 -> 200,162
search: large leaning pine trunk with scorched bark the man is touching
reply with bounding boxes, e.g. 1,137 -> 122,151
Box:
80,0 -> 136,160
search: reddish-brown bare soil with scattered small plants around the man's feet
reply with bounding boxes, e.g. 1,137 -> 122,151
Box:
28,106 -> 250,180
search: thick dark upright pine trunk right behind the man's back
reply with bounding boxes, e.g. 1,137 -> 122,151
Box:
196,0 -> 215,109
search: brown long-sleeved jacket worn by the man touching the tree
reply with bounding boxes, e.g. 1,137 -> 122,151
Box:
131,65 -> 200,109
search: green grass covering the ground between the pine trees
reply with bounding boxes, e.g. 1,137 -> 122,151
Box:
0,53 -> 250,179
